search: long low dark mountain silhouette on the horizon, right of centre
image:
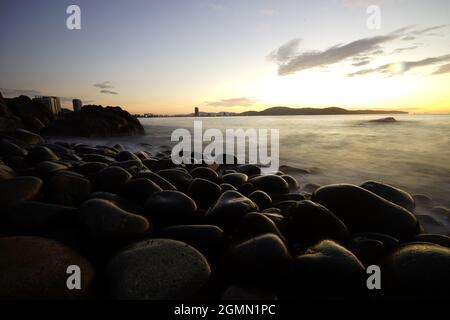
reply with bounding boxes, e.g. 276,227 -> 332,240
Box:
238,107 -> 408,116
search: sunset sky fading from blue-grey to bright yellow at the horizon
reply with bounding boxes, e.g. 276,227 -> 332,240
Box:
0,0 -> 450,114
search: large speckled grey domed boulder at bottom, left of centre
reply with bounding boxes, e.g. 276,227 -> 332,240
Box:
107,239 -> 211,300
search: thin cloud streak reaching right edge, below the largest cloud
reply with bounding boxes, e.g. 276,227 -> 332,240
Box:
348,54 -> 450,77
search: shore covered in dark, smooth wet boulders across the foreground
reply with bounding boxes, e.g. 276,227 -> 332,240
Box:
0,132 -> 450,300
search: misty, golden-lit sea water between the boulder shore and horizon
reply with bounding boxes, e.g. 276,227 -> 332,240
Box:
59,115 -> 450,207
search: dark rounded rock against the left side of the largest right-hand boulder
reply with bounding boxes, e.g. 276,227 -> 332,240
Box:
286,200 -> 349,245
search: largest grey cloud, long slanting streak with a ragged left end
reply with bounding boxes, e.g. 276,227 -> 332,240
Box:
269,26 -> 412,75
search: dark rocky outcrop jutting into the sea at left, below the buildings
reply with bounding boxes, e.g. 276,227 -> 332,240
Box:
43,105 -> 144,137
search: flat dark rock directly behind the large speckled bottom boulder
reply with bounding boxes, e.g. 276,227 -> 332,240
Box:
160,224 -> 225,257
